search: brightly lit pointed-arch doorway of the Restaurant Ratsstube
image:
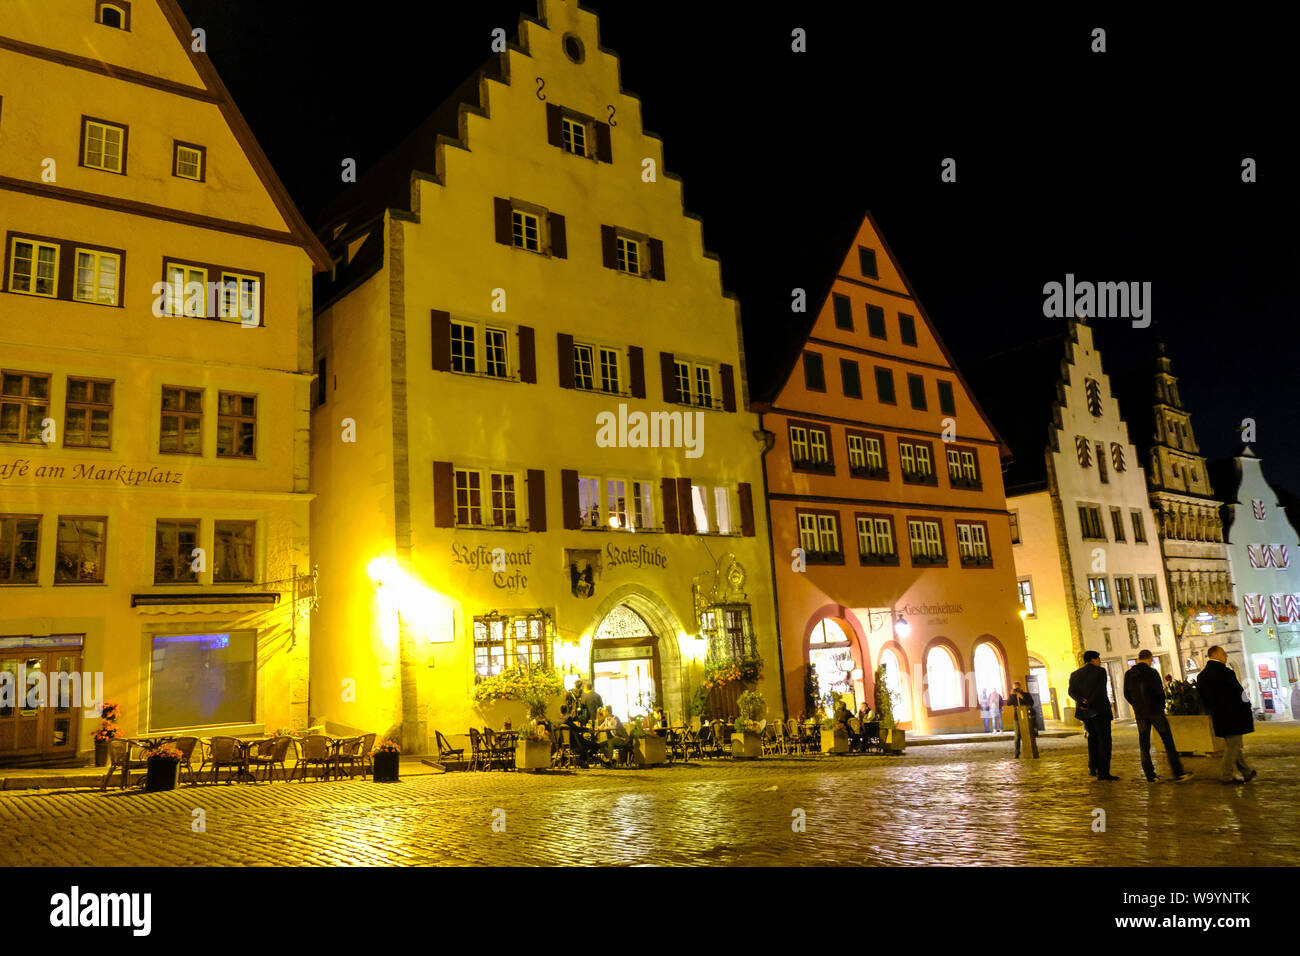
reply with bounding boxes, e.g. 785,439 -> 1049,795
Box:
592,604 -> 663,721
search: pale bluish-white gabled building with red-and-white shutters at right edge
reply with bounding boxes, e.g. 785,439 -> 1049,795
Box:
1210,447 -> 1300,717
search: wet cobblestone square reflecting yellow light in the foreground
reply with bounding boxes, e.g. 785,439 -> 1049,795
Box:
0,723 -> 1300,866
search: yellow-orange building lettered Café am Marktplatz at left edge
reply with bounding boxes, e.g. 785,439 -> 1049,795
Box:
0,0 -> 328,762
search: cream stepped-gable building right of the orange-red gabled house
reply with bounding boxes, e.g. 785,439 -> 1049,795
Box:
974,320 -> 1180,718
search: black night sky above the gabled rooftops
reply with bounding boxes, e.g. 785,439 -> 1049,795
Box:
181,0 -> 1300,502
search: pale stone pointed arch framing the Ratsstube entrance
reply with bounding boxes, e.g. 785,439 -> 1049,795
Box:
582,584 -> 685,719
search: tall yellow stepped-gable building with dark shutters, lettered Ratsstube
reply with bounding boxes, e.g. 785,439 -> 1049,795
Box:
312,0 -> 781,752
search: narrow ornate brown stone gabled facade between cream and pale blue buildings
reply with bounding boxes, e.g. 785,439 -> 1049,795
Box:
1147,345 -> 1244,676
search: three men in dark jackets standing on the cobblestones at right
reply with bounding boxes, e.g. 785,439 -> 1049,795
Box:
1069,646 -> 1256,783
